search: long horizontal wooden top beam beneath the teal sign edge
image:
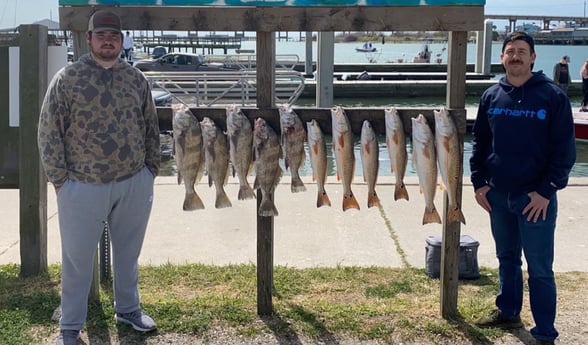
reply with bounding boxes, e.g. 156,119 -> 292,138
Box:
59,6 -> 484,32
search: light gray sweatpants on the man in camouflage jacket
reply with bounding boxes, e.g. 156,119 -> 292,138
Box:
57,167 -> 154,330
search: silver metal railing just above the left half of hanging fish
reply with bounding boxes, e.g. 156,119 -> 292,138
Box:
145,70 -> 304,107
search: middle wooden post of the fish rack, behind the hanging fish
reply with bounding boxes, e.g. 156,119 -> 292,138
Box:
256,32 -> 276,315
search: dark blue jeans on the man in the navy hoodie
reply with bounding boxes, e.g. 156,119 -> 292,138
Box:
487,189 -> 559,341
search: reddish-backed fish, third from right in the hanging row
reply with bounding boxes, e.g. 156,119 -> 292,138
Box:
384,107 -> 408,200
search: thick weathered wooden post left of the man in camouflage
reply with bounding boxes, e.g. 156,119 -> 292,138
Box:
18,25 -> 48,277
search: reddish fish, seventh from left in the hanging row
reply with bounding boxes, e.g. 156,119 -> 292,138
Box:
331,107 -> 359,211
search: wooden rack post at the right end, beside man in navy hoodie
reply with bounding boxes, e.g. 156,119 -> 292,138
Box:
441,31 -> 468,319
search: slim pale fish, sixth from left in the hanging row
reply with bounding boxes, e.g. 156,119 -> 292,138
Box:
306,120 -> 331,207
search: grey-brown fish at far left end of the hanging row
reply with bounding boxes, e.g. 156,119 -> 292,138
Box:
172,104 -> 204,211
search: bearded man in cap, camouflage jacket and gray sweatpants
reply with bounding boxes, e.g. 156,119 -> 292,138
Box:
37,11 -> 160,345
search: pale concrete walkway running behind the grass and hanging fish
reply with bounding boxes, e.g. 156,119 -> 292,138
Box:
0,176 -> 588,272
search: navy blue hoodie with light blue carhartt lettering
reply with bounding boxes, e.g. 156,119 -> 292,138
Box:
470,72 -> 576,199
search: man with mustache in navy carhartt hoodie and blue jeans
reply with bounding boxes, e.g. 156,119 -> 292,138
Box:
470,32 -> 576,344
